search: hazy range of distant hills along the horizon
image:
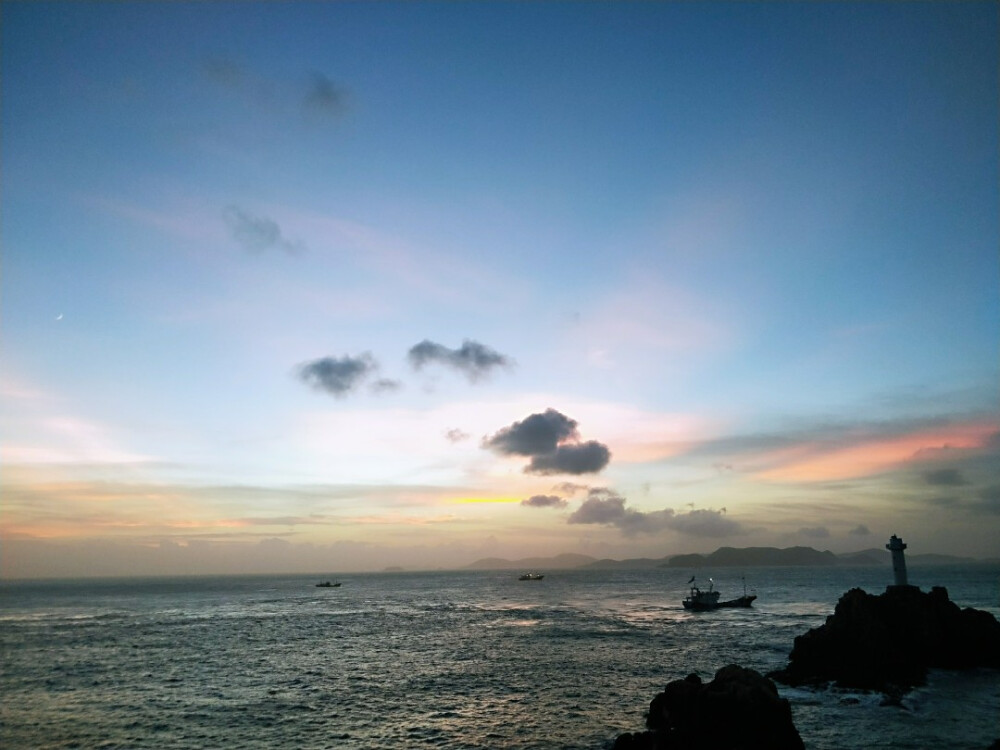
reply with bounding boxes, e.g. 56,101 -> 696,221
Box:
465,547 -> 979,570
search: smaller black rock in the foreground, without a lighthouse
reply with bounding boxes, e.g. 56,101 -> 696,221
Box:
614,664 -> 804,750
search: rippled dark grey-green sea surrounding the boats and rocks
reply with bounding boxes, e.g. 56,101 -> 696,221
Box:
0,565 -> 1000,750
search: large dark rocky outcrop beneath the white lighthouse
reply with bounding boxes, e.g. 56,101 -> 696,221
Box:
770,586 -> 1000,695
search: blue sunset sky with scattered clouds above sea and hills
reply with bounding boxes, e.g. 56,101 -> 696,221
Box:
0,1 -> 1000,578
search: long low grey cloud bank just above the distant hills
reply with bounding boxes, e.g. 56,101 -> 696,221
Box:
566,488 -> 744,537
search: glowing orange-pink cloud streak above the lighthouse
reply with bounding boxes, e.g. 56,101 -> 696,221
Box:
754,423 -> 1000,482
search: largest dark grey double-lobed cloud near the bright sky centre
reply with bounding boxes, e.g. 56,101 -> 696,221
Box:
482,408 -> 611,475
